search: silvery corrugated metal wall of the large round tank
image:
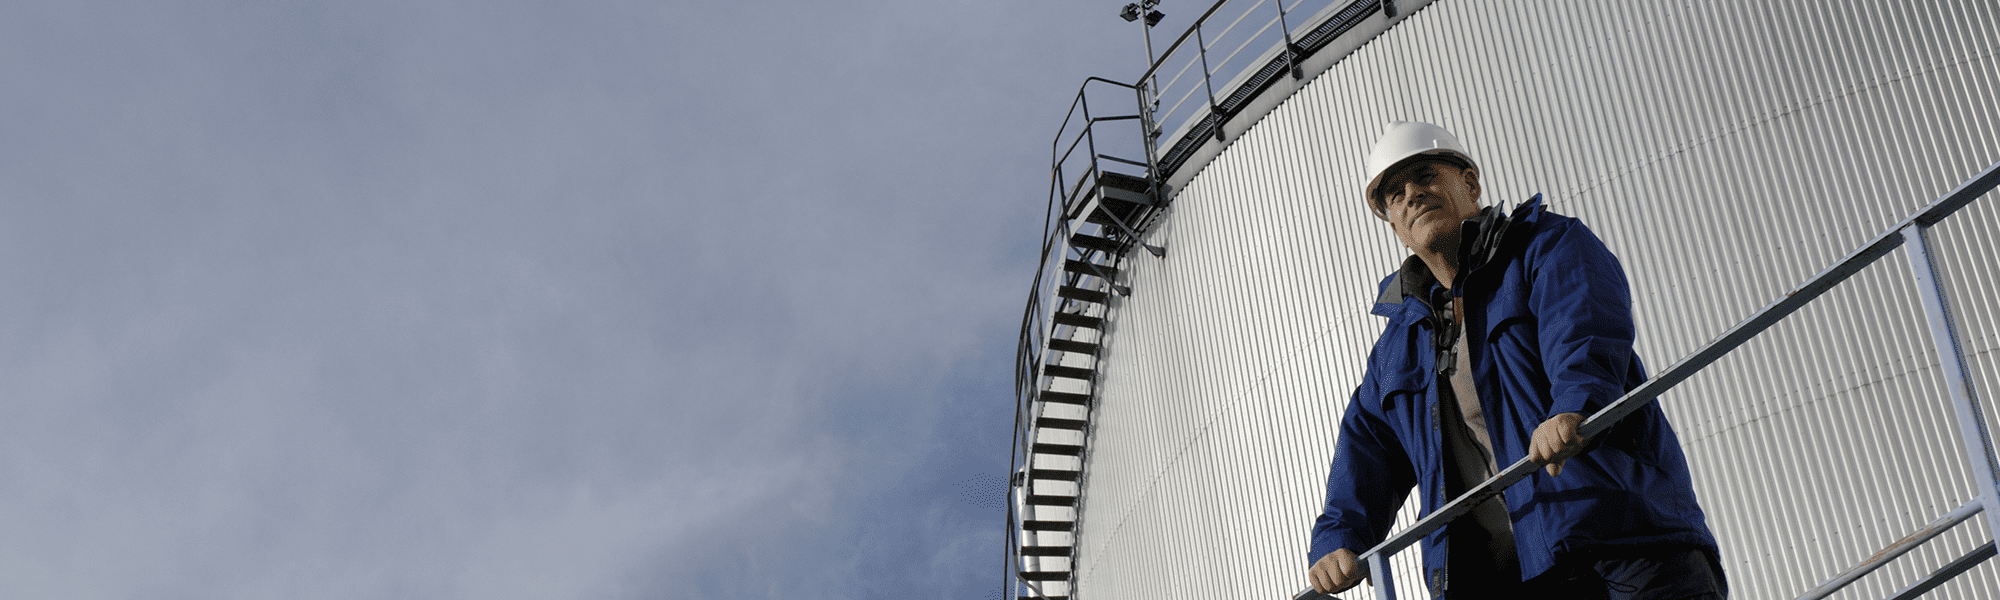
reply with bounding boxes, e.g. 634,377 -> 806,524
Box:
1076,0 -> 2000,598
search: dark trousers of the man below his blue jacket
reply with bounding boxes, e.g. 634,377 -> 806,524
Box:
1448,548 -> 1728,600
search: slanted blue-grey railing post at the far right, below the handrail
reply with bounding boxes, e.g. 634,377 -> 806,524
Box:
1902,222 -> 2000,540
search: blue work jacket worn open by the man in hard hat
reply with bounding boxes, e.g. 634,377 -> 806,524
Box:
1308,196 -> 1720,594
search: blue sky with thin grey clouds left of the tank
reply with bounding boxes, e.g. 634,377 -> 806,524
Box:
0,0 -> 1152,598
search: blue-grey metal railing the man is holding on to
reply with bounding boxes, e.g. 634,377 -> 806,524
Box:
1292,164 -> 2000,600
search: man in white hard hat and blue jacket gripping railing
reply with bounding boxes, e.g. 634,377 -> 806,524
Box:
1308,122 -> 1726,598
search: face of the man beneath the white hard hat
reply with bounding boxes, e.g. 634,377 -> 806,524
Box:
1376,160 -> 1480,256
